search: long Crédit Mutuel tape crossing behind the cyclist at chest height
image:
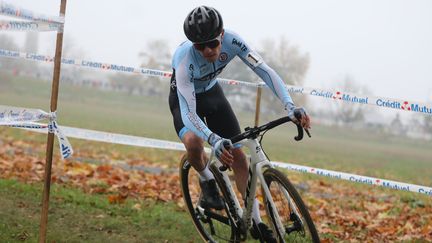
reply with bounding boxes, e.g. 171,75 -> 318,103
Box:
0,49 -> 432,115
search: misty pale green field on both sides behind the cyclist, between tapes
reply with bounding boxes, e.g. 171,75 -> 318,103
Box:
0,72 -> 432,186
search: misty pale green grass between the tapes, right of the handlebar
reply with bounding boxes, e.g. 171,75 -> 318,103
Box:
264,123 -> 432,186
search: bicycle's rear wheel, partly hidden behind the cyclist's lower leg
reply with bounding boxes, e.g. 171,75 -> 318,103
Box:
180,155 -> 237,242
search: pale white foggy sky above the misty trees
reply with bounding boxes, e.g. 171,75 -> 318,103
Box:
0,0 -> 432,103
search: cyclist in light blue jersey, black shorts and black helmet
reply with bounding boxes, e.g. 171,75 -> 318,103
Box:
169,6 -> 310,242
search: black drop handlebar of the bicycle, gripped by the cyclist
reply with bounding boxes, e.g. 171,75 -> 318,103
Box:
219,114 -> 311,171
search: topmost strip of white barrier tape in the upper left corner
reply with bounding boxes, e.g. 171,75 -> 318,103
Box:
0,1 -> 65,24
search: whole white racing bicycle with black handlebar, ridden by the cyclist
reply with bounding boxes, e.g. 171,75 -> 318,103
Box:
180,114 -> 320,242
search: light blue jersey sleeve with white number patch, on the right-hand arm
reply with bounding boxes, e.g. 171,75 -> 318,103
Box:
228,32 -> 294,109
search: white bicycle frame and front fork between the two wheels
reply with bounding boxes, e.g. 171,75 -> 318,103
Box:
210,139 -> 285,235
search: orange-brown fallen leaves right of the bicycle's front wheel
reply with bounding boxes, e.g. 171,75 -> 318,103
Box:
304,181 -> 432,242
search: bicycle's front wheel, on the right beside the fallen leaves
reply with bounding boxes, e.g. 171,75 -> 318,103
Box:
263,168 -> 320,242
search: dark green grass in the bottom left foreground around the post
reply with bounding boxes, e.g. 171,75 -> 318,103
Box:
0,179 -> 200,242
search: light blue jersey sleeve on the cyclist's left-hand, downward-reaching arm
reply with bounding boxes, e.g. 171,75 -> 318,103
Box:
176,51 -> 212,141
